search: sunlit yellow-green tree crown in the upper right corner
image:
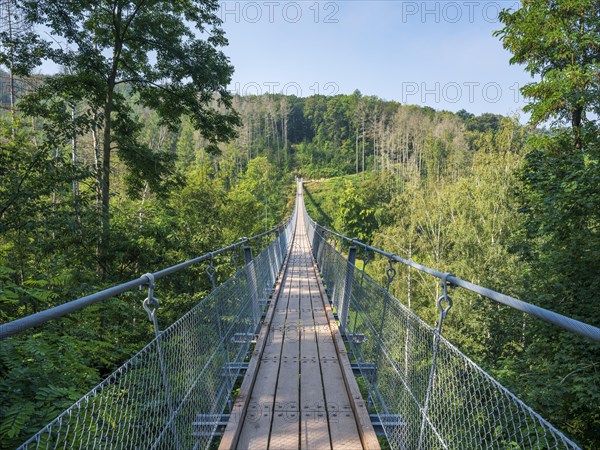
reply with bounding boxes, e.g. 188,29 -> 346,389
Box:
495,0 -> 600,149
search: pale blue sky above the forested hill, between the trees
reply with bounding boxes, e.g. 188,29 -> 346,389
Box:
220,0 -> 530,118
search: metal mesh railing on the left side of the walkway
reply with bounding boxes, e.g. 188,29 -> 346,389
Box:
20,208 -> 296,449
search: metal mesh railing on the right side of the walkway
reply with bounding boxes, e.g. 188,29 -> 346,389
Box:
303,200 -> 579,450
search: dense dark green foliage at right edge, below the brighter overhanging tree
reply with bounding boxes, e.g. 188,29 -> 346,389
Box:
513,134 -> 600,444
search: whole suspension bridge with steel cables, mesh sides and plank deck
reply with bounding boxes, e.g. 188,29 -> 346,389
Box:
0,181 -> 600,449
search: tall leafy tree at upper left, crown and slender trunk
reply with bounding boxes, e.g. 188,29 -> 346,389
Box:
22,0 -> 238,270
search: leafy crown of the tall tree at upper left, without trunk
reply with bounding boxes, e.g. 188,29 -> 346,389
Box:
22,0 -> 237,138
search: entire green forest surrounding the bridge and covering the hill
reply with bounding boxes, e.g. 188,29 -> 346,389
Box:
0,0 -> 600,448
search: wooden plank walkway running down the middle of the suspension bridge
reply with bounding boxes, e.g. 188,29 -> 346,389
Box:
219,194 -> 379,450
